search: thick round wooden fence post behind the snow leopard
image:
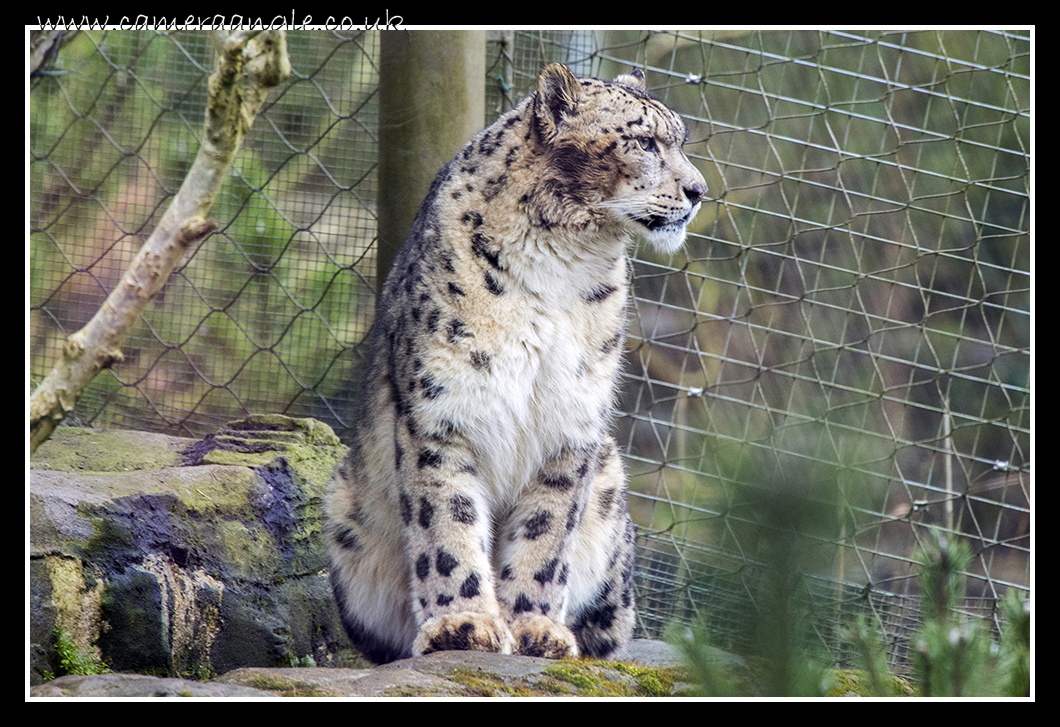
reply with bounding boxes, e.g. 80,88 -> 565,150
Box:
376,31 -> 485,289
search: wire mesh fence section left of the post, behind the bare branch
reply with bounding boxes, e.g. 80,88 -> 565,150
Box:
30,31 -> 378,435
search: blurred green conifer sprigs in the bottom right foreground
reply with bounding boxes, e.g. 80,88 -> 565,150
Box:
668,521 -> 1030,697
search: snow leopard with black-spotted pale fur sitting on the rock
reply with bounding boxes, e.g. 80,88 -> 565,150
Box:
325,65 -> 706,662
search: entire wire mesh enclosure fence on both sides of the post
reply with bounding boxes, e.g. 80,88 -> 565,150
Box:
29,30 -> 1031,678
